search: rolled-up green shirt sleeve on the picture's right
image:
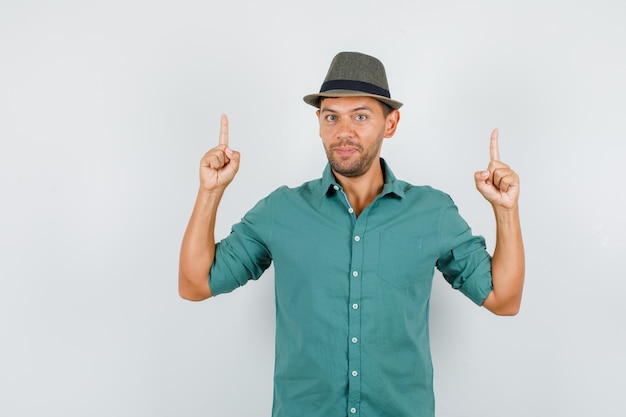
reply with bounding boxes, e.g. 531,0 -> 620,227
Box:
437,200 -> 493,305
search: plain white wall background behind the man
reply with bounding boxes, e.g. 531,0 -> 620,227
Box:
0,0 -> 626,417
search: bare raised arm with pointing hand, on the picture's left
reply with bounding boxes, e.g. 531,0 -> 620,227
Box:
178,115 -> 240,301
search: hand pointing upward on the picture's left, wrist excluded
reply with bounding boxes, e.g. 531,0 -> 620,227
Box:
200,114 -> 241,192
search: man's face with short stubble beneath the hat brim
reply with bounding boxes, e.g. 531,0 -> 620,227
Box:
317,97 -> 399,177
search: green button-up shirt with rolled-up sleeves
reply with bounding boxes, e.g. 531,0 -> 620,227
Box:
209,159 -> 492,417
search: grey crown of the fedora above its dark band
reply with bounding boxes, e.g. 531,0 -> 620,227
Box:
324,52 -> 389,91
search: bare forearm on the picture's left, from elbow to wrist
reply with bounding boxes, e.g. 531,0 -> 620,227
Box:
178,190 -> 223,301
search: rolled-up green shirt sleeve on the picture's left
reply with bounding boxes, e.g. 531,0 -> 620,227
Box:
209,195 -> 272,295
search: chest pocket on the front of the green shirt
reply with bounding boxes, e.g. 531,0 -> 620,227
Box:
377,232 -> 434,289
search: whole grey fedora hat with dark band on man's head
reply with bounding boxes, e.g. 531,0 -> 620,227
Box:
304,52 -> 402,109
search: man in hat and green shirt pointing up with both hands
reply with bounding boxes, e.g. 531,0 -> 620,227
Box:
179,52 -> 524,417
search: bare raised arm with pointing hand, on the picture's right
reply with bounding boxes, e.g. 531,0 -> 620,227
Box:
474,129 -> 525,316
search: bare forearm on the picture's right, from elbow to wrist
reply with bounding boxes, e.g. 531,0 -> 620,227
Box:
484,206 -> 525,315
